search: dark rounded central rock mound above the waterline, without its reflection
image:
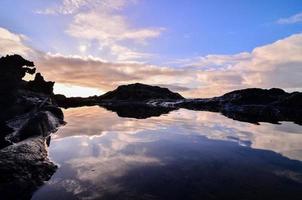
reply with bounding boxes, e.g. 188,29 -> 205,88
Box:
99,83 -> 184,101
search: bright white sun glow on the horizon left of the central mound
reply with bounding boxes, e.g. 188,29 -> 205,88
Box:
54,83 -> 104,97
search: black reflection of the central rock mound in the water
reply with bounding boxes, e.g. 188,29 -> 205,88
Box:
100,102 -> 175,119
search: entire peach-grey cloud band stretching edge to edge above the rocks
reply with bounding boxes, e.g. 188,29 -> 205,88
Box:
0,28 -> 302,97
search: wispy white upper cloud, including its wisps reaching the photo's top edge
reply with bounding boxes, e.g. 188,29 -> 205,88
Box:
38,0 -> 164,61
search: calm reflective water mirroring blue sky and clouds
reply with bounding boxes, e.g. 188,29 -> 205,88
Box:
33,107 -> 302,200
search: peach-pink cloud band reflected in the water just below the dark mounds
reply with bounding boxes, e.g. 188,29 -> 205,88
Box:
55,107 -> 302,160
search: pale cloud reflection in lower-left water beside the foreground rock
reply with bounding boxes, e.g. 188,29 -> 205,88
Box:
50,133 -> 162,199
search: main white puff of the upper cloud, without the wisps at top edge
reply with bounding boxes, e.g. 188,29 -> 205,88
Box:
66,8 -> 164,61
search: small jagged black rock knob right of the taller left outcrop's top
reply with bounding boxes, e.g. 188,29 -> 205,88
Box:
26,73 -> 55,95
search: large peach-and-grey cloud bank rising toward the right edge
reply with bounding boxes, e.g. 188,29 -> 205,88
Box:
182,34 -> 302,96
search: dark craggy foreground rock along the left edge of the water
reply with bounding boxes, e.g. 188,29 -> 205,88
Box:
0,55 -> 64,199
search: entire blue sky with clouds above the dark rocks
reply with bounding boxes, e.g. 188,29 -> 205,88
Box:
0,0 -> 302,97
